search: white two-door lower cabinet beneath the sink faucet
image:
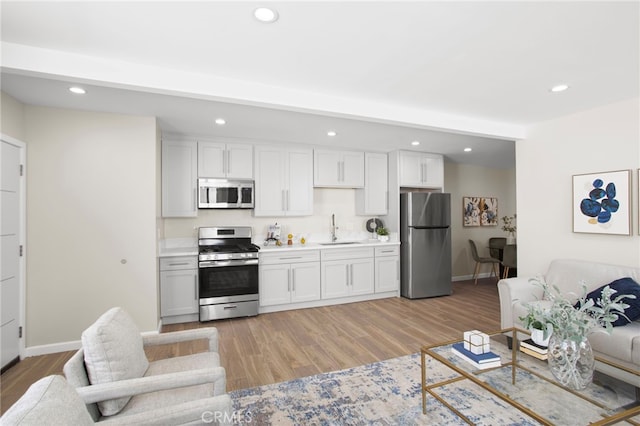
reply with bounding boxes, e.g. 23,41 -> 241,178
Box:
321,247 -> 374,299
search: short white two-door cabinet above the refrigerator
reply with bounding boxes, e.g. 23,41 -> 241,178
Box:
400,151 -> 444,188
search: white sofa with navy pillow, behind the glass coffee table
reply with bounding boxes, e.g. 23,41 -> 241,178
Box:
498,259 -> 640,387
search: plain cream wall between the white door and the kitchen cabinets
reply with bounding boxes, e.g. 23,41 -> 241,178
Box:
25,106 -> 158,348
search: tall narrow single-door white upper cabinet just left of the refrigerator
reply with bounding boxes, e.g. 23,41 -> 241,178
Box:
356,152 -> 389,215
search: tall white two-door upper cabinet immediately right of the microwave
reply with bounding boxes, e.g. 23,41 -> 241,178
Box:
253,146 -> 313,216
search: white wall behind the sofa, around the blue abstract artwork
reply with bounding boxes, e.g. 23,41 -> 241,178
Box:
516,98 -> 640,276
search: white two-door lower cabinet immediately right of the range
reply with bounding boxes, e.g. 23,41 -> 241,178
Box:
260,250 -> 320,306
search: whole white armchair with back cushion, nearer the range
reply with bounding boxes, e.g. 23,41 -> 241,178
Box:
64,308 -> 232,423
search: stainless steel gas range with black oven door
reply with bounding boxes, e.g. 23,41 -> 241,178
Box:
198,226 -> 259,321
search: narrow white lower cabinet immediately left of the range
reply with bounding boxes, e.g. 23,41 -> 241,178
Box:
160,256 -> 198,318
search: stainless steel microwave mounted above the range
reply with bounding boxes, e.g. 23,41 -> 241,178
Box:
198,179 -> 254,209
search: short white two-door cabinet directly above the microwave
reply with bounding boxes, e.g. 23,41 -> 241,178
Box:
198,141 -> 253,179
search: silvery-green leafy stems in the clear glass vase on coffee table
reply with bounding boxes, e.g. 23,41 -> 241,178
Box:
520,278 -> 635,343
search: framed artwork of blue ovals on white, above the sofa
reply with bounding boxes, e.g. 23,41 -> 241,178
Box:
572,170 -> 631,235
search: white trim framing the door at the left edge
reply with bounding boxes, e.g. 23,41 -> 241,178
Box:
0,133 -> 27,360
